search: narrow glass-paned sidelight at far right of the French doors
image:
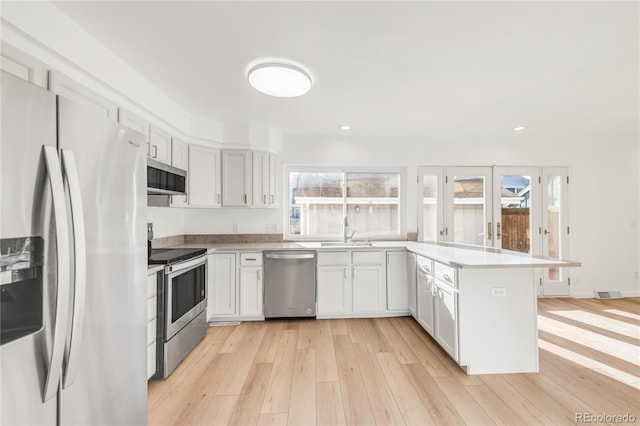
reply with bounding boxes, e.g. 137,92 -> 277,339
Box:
542,167 -> 569,296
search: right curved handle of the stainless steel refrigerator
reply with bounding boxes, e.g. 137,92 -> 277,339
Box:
62,149 -> 87,388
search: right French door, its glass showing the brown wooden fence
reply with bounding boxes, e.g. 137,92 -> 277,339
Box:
490,167 -> 542,254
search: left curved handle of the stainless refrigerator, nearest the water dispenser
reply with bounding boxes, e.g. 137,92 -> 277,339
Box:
42,146 -> 70,402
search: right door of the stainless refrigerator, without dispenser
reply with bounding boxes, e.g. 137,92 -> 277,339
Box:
58,97 -> 147,425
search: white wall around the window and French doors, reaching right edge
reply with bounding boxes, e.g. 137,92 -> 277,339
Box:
280,132 -> 640,297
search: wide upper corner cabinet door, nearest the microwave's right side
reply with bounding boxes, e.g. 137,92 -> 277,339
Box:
187,144 -> 221,207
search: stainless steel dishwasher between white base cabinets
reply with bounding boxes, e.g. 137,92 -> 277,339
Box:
264,250 -> 316,318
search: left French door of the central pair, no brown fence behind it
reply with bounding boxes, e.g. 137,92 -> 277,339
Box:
445,167 -> 493,246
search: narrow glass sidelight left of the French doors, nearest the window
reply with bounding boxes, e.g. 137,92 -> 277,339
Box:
418,167 -> 445,241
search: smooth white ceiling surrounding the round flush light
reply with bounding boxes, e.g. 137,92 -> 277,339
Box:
51,1 -> 639,140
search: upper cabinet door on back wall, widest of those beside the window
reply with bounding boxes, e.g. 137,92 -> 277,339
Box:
222,149 -> 252,207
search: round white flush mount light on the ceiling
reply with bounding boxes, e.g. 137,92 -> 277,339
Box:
248,62 -> 311,98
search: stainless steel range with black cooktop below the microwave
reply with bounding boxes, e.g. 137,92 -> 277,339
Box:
149,248 -> 207,379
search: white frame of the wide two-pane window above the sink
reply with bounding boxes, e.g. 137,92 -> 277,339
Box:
282,164 -> 407,241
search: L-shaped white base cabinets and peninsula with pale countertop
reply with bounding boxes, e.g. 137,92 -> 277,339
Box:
161,241 -> 580,374
